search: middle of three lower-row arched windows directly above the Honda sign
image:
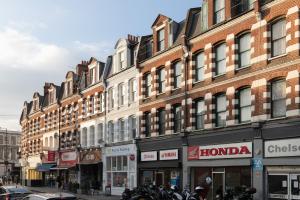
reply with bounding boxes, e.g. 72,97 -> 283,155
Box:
216,94 -> 226,127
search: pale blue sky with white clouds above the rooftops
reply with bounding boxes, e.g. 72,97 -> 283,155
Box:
0,0 -> 201,130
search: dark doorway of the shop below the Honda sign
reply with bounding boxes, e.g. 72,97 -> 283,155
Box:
212,172 -> 225,199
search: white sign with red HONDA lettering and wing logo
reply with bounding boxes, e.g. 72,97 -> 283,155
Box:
188,142 -> 252,160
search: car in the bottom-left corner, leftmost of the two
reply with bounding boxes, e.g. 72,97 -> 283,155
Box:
0,186 -> 32,200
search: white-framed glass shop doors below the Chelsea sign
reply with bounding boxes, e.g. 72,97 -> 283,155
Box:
268,174 -> 300,200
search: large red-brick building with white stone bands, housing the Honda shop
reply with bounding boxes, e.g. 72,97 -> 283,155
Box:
139,0 -> 300,199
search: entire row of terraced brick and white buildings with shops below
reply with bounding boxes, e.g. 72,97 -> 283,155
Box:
20,0 -> 300,199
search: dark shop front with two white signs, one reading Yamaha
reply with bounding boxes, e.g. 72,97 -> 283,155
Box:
139,149 -> 181,187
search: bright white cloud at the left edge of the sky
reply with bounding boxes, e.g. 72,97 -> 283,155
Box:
0,27 -> 72,71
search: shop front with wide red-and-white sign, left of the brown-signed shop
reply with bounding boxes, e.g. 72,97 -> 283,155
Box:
54,151 -> 78,188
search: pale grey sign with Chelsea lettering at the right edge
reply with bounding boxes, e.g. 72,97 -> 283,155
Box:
265,138 -> 300,157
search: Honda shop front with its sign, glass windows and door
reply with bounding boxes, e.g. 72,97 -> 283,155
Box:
186,142 -> 253,200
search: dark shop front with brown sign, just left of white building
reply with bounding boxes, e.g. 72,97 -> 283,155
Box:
79,149 -> 103,190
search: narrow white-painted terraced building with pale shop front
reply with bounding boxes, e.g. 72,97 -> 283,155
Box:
102,36 -> 139,195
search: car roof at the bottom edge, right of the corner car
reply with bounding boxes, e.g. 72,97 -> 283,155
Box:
23,192 -> 77,200
